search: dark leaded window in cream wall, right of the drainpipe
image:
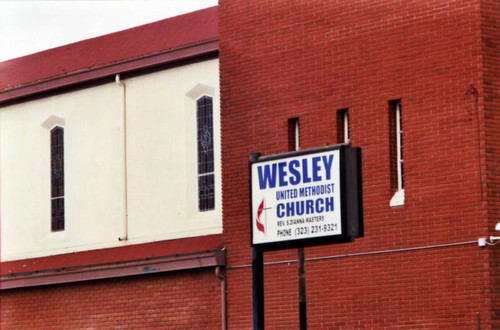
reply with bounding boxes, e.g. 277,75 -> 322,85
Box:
196,96 -> 215,211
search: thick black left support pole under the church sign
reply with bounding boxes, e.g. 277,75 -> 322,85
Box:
252,247 -> 264,330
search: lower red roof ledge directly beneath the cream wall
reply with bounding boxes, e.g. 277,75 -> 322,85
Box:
0,234 -> 225,290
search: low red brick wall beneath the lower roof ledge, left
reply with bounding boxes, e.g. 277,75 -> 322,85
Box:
0,268 -> 221,329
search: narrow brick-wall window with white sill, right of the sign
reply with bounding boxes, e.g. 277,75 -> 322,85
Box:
389,100 -> 404,206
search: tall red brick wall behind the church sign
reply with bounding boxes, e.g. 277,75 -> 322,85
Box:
219,0 -> 498,329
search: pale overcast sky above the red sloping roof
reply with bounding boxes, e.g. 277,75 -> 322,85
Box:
0,0 -> 217,61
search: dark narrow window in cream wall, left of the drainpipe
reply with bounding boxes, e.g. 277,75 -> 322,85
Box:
50,126 -> 64,231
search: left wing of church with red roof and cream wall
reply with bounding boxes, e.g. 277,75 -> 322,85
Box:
0,8 -> 224,328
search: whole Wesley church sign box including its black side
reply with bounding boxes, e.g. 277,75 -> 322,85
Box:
250,145 -> 363,249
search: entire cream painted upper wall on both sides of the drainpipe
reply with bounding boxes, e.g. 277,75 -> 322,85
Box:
0,60 -> 222,261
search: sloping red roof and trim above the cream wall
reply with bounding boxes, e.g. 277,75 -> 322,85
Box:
0,7 -> 218,103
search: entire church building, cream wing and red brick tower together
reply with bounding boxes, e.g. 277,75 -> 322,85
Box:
0,0 -> 500,329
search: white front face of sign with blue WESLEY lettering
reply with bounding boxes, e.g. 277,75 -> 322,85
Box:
250,149 -> 343,245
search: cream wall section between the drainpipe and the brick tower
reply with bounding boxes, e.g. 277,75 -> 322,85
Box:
126,60 -> 222,240
